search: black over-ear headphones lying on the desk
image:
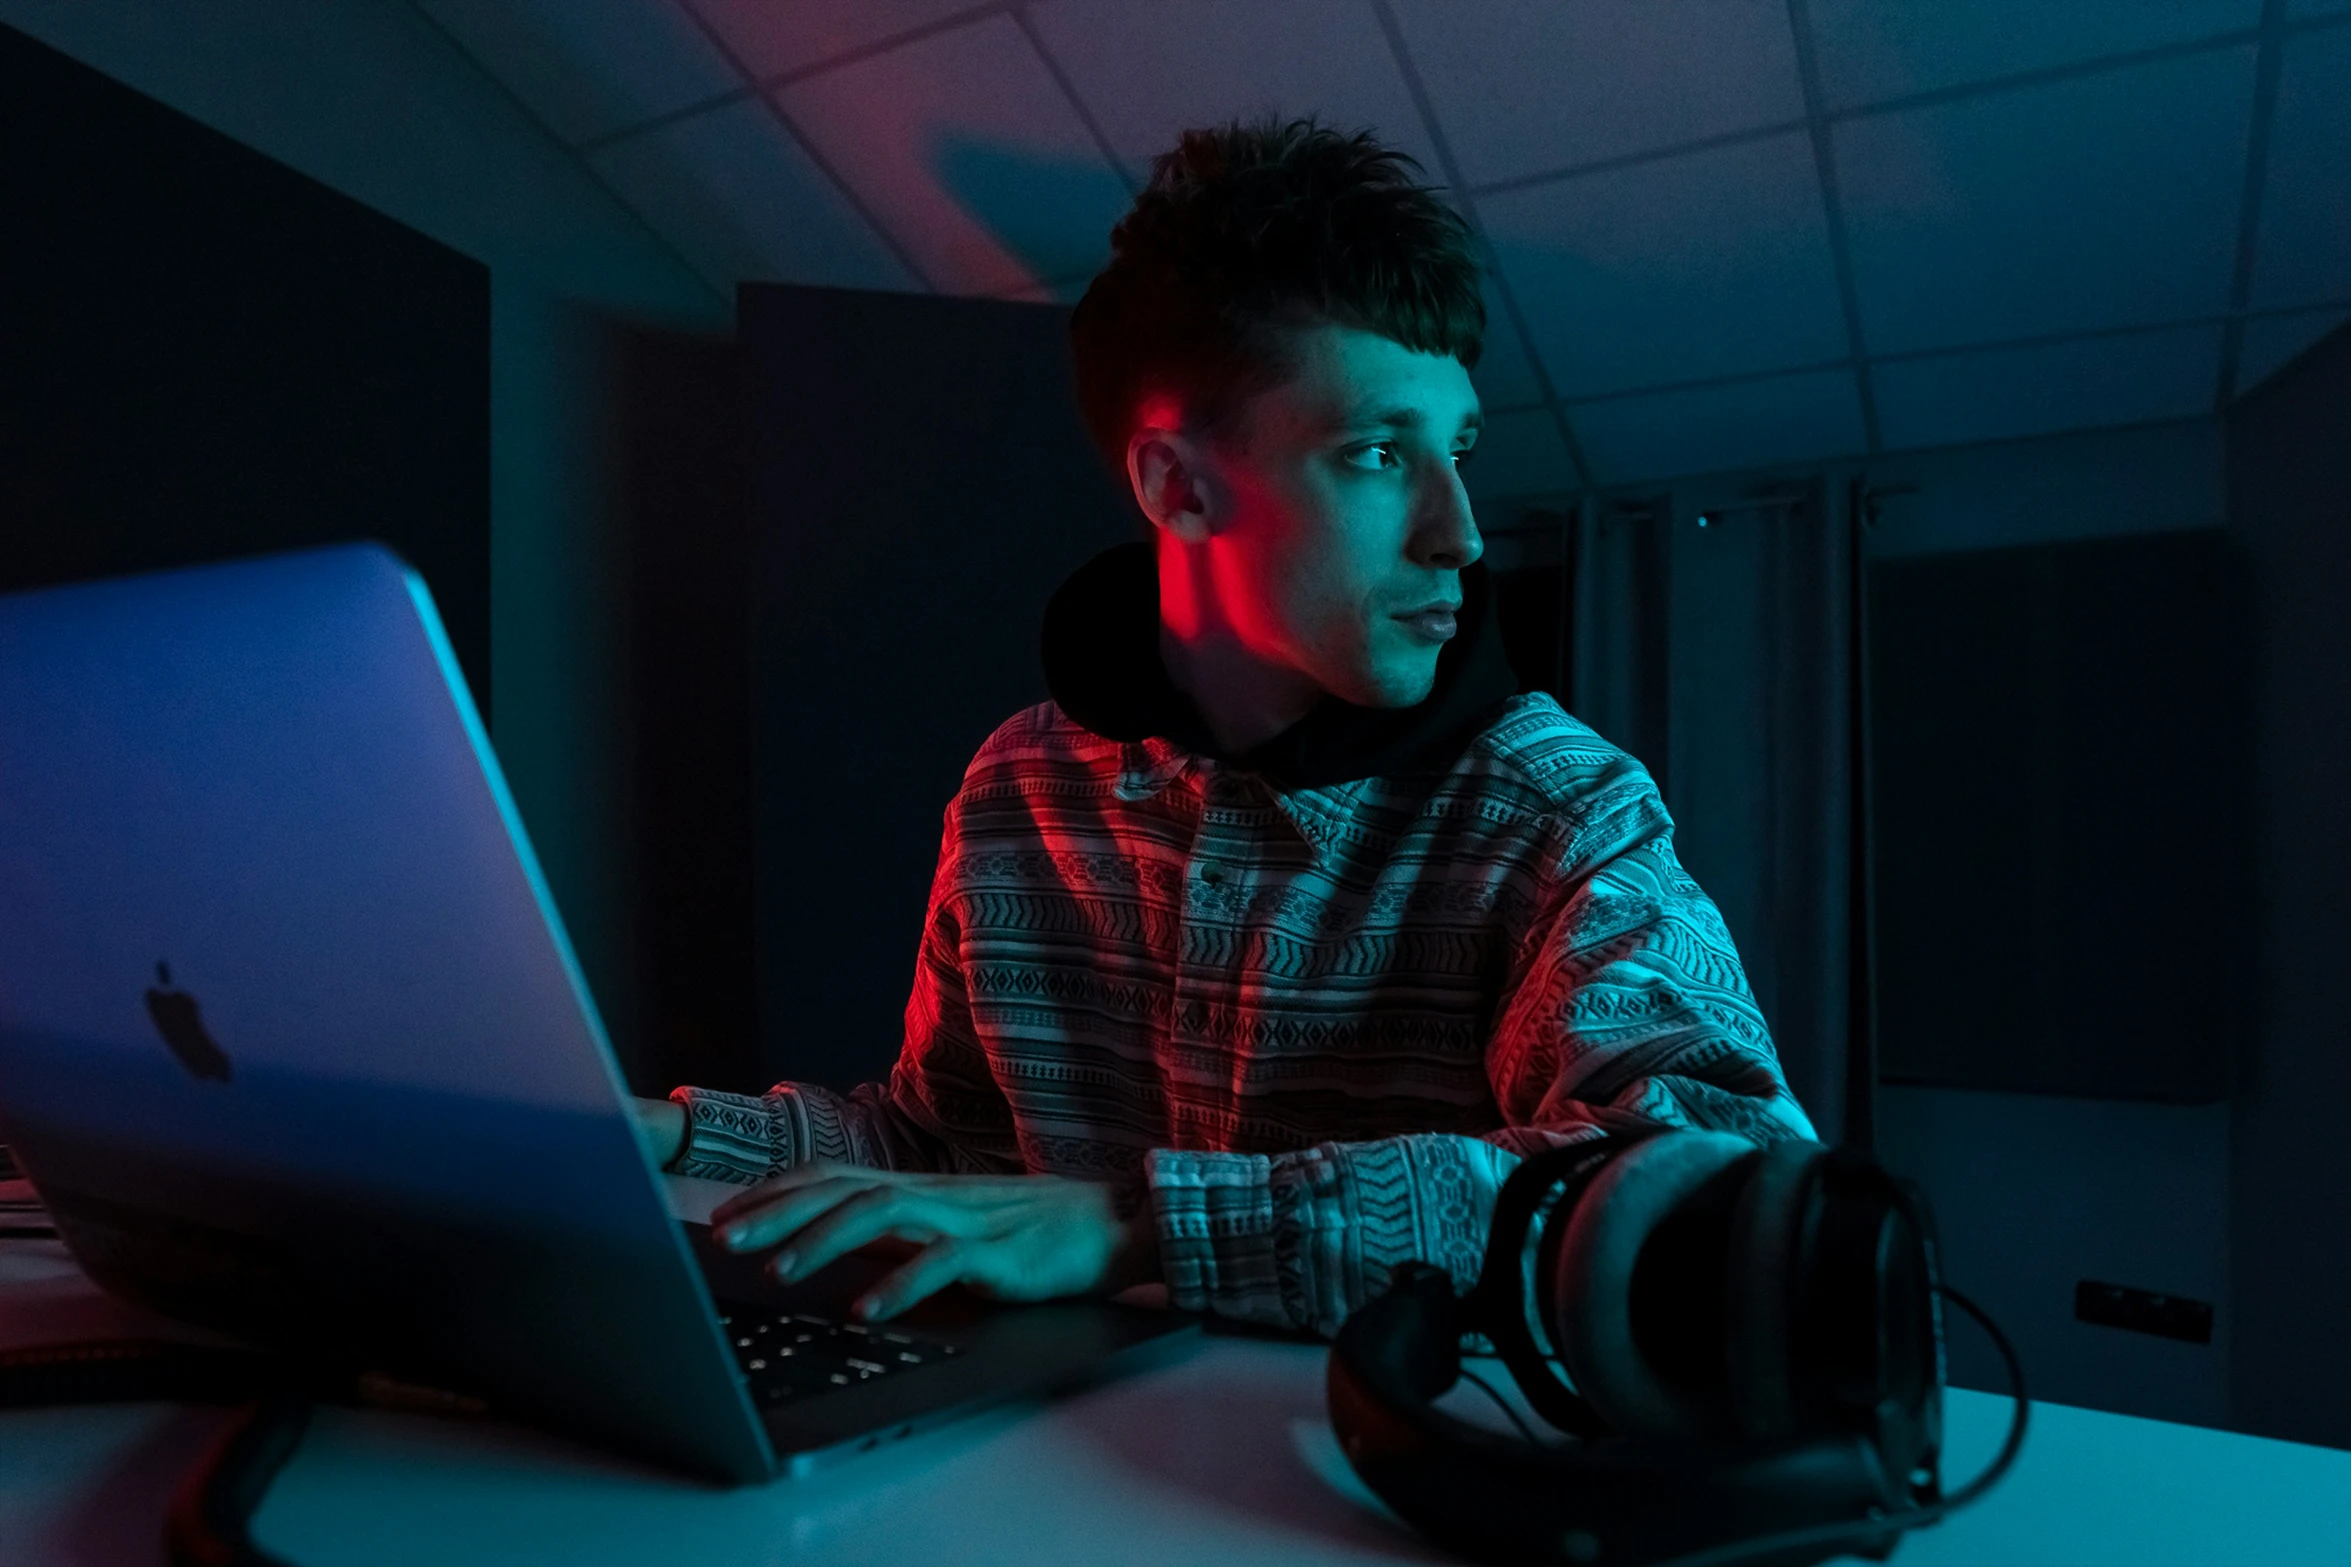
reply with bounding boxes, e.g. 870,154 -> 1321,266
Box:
1328,1132 -> 2027,1567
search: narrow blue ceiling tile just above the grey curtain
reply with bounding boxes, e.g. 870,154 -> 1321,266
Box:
1568,369 -> 1864,484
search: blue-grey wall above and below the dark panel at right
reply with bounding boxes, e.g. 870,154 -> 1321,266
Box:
1864,421 -> 2236,1426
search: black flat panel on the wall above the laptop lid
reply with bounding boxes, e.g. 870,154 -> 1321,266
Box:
0,16 -> 489,709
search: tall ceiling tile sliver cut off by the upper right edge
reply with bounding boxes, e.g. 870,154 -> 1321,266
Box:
2252,28 -> 2351,308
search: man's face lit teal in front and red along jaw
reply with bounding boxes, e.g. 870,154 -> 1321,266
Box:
1175,324 -> 1483,707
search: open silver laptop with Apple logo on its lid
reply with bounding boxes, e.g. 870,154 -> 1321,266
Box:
0,545 -> 1199,1482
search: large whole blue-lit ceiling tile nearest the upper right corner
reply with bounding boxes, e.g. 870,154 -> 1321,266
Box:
1834,47 -> 2252,352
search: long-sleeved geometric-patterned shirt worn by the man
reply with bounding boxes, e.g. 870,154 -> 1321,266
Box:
670,552 -> 1813,1334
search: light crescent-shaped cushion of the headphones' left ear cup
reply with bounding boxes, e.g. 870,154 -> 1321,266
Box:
1552,1132 -> 1756,1435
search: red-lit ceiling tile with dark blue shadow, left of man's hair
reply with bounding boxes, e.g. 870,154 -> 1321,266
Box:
778,16 -> 1131,294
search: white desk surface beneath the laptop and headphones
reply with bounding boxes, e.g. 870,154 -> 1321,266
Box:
0,1184 -> 2351,1567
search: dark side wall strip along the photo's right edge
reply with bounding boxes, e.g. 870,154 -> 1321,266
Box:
2229,321 -> 2351,1447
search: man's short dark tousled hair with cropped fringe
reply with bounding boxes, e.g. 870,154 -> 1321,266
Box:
1070,120 -> 1486,472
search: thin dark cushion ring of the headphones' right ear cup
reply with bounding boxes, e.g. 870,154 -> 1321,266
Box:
1723,1142 -> 1829,1438
